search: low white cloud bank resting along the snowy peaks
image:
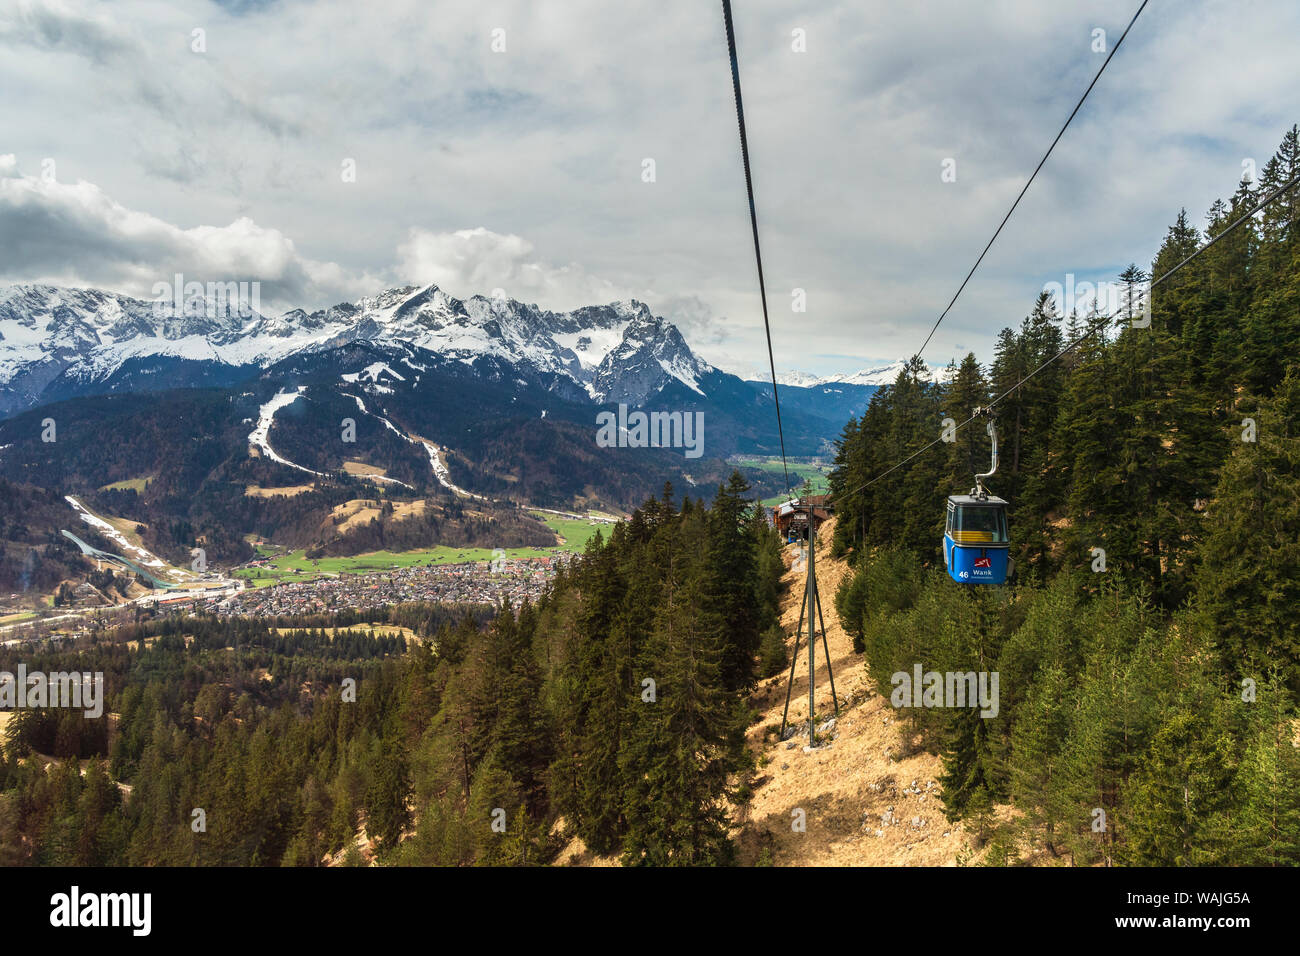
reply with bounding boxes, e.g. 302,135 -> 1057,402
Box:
0,153 -> 639,317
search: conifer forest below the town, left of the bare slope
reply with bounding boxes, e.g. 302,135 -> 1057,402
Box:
0,475 -> 781,865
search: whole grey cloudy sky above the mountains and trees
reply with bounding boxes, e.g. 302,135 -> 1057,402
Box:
0,0 -> 1300,382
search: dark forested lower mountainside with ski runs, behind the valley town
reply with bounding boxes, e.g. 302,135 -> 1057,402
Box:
0,377 -> 780,582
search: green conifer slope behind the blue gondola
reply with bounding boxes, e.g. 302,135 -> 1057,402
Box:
831,127 -> 1300,865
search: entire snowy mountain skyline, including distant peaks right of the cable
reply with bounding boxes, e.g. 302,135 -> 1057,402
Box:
0,285 -> 944,442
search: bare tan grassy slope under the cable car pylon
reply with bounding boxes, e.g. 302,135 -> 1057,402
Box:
737,519 -> 969,866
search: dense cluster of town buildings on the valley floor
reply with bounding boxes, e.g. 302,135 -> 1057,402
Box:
210,554 -> 569,617
